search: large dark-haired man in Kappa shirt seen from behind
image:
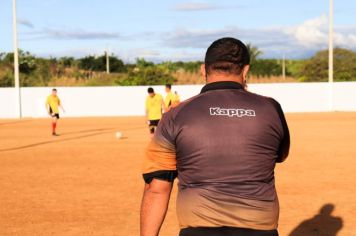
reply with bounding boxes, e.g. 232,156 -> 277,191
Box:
141,38 -> 290,236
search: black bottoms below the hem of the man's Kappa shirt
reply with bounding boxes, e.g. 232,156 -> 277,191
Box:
179,227 -> 278,236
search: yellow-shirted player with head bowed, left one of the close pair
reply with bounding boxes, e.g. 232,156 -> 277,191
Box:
146,87 -> 165,136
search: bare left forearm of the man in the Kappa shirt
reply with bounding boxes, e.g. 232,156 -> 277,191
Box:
140,179 -> 173,236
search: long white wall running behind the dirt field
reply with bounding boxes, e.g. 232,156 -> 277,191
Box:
0,82 -> 356,118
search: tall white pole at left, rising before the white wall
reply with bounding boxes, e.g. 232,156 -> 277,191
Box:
12,0 -> 22,118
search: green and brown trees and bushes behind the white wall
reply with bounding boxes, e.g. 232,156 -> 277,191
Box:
0,44 -> 356,87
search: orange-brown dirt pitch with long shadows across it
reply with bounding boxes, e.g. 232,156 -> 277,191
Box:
0,113 -> 356,236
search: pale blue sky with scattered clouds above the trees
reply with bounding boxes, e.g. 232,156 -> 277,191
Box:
0,0 -> 356,61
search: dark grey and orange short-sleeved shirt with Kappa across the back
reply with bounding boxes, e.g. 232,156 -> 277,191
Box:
143,82 -> 290,230
